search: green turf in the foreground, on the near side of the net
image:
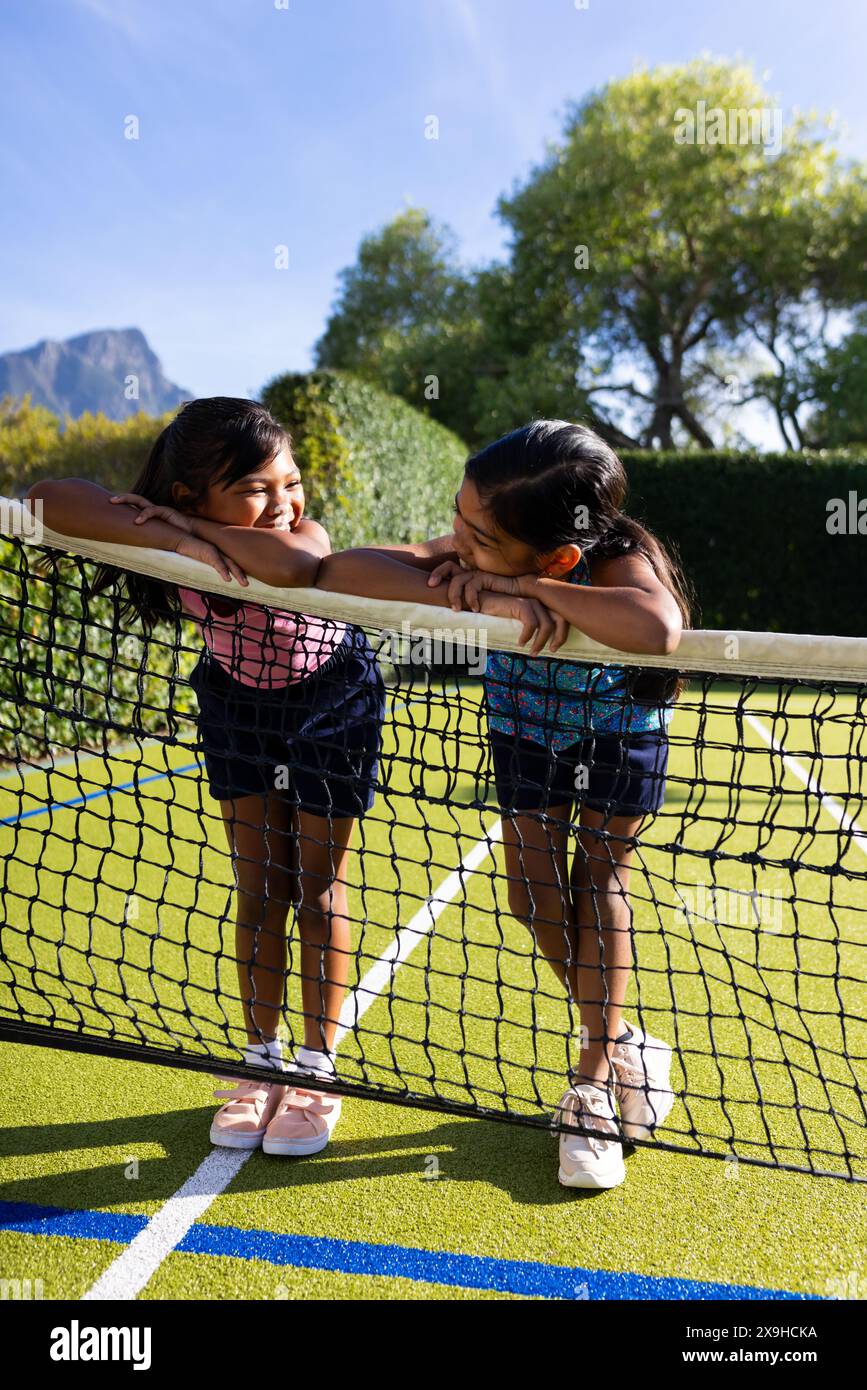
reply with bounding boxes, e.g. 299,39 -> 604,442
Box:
0,1044 -> 867,1298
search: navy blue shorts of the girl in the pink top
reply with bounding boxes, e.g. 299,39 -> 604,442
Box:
190,627 -> 385,820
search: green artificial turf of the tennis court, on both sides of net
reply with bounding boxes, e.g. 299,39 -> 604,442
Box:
0,687 -> 867,1298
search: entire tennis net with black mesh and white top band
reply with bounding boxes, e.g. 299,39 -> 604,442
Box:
0,503 -> 867,1180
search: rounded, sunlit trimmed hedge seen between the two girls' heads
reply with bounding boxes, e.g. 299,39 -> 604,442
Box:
263,371 -> 468,550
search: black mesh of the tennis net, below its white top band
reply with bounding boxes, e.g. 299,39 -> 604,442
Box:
0,541 -> 867,1180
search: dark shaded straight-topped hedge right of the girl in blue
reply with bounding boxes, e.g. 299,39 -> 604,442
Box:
621,450 -> 867,637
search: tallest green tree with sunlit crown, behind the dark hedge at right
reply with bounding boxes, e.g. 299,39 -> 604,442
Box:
500,60 -> 867,448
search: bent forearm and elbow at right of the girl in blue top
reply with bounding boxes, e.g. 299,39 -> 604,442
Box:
518,555 -> 684,656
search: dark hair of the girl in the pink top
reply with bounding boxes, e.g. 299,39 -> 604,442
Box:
90,396 -> 292,627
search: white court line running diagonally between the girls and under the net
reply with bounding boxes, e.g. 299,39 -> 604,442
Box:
82,820 -> 502,1301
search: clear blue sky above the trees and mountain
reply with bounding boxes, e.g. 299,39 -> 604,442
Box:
0,0 -> 867,411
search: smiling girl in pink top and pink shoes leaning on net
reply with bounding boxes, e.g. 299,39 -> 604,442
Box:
31,396 -> 385,1154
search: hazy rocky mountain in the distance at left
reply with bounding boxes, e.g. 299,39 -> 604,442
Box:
0,328 -> 192,420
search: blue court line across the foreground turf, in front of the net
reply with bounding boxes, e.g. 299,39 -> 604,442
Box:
0,1201 -> 820,1302
